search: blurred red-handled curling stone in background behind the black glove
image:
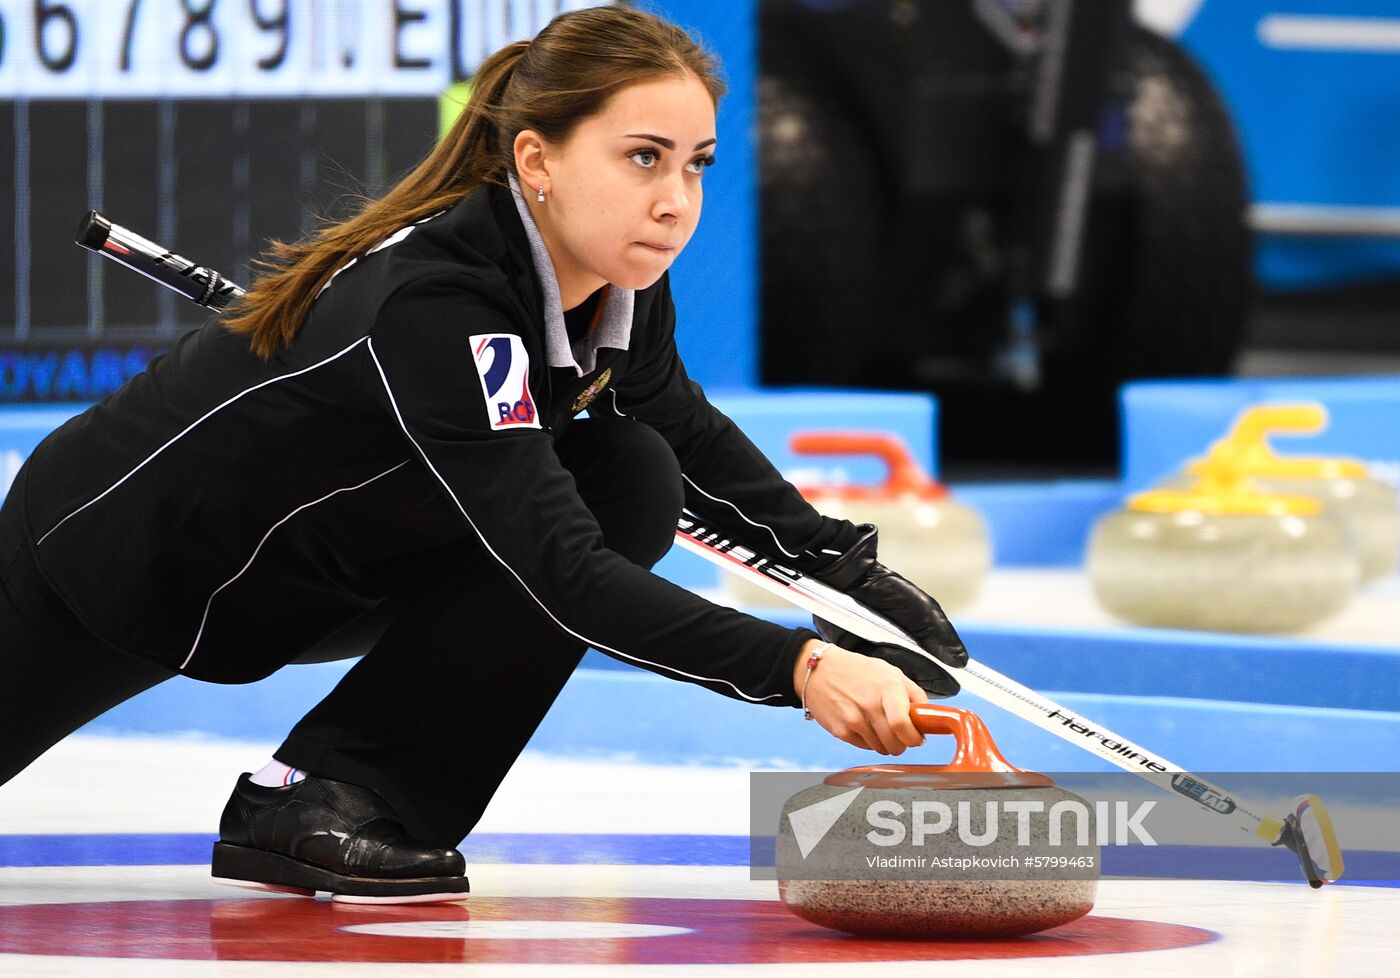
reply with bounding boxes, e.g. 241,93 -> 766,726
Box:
725,431 -> 991,611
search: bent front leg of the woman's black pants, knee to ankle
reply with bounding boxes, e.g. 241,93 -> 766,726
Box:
276,418 -> 683,845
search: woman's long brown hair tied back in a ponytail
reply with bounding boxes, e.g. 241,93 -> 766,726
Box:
224,7 -> 725,358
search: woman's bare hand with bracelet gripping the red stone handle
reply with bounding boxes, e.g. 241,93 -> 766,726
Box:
792,639 -> 928,756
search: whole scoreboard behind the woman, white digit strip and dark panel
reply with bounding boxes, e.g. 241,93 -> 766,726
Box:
0,0 -> 610,402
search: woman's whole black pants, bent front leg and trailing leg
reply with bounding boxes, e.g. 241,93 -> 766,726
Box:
0,418 -> 683,845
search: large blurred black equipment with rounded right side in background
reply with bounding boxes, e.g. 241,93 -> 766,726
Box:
760,0 -> 1250,462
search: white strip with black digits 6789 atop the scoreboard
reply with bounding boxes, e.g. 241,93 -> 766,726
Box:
0,0 -> 596,99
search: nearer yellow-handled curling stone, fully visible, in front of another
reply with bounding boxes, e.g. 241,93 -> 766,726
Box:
1086,456 -> 1359,632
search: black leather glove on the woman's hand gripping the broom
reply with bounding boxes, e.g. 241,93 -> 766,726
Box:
813,523 -> 967,695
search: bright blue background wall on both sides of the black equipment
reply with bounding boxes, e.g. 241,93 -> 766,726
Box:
647,0 -> 1400,389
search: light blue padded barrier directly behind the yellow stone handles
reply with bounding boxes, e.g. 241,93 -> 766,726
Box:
1120,376 -> 1400,492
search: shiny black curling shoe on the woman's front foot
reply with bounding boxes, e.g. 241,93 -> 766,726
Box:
213,774 -> 469,904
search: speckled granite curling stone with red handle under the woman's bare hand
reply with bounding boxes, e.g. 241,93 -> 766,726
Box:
776,704 -> 1099,940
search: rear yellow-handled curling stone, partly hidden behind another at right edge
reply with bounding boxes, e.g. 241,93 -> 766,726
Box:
1169,404 -> 1400,582
